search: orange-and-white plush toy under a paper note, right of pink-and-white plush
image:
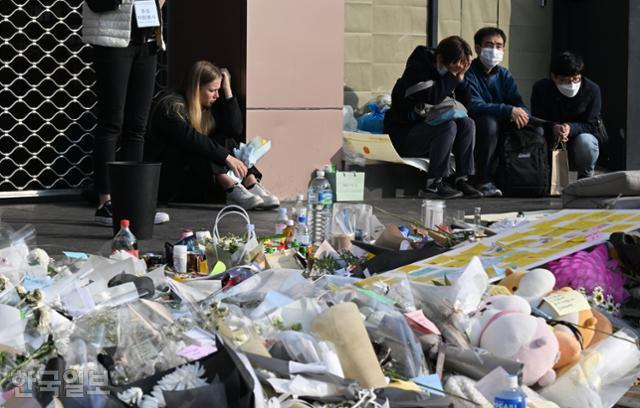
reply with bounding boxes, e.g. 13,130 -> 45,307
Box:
539,288 -> 598,349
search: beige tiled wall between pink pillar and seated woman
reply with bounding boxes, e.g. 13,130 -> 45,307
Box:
344,0 -> 427,108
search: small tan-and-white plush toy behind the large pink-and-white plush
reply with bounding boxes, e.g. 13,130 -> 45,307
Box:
499,268 -> 556,307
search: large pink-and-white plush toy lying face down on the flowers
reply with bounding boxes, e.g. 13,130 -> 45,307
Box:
470,295 -> 558,387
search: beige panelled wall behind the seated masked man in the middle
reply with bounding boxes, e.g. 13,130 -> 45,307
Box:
438,0 -> 553,105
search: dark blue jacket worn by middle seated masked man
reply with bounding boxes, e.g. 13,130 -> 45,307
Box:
463,58 -> 529,120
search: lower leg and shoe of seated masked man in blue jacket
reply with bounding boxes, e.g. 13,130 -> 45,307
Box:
474,116 -> 502,197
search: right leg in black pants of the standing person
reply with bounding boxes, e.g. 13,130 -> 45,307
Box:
122,43 -> 158,161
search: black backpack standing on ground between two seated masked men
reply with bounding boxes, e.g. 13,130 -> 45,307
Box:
496,126 -> 550,197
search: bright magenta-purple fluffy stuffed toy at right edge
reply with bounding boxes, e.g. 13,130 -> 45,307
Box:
548,244 -> 629,306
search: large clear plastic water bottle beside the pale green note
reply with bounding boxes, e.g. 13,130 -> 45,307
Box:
307,170 -> 333,244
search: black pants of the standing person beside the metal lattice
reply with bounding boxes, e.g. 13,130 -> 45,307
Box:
93,42 -> 157,194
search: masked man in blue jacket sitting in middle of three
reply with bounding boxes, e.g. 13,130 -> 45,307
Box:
464,27 -> 529,197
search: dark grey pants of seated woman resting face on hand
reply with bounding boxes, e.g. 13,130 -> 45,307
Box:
394,118 -> 475,179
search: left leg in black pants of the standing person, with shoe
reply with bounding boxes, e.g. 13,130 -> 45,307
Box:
93,46 -> 133,205
